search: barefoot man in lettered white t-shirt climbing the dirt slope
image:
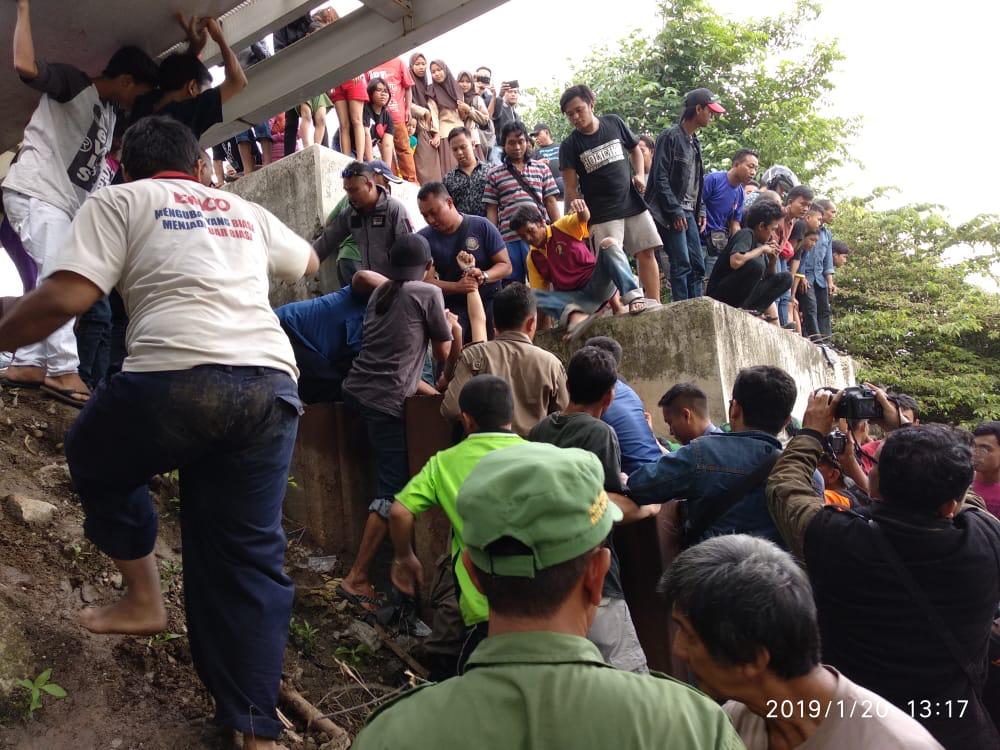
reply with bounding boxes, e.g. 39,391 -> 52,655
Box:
0,116 -> 319,750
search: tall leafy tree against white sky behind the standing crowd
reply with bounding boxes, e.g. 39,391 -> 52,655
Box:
530,0 -> 857,182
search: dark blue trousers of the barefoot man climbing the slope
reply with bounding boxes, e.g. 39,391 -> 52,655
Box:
66,365 -> 301,737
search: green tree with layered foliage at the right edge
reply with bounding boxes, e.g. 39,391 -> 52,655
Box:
833,195 -> 1000,426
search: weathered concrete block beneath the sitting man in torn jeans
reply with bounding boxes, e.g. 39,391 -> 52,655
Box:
535,297 -> 854,434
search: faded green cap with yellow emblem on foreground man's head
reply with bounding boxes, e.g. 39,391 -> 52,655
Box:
457,443 -> 622,578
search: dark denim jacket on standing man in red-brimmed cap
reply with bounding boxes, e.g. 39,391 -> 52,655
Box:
646,122 -> 705,227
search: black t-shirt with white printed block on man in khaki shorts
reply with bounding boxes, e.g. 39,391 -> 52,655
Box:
559,115 -> 646,224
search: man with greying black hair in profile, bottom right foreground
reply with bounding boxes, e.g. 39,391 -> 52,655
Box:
660,534 -> 940,750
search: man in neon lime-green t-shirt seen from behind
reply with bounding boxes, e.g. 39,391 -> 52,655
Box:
389,374 -> 525,681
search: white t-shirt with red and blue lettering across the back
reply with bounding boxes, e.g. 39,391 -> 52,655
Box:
53,172 -> 312,377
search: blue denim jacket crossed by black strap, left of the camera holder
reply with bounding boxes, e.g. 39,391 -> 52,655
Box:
626,431 -> 823,548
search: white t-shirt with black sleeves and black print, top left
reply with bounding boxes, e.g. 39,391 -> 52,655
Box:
3,61 -> 115,217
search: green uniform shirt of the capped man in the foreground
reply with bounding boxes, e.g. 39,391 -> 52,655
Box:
353,632 -> 744,750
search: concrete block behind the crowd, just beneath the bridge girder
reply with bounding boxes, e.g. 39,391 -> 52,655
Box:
226,145 -> 425,307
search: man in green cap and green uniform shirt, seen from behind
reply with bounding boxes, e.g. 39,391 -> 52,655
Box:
354,444 -> 742,750
